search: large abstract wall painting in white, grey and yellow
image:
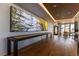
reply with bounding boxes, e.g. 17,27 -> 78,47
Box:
10,6 -> 48,32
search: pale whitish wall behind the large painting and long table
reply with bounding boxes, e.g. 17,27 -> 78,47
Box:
0,4 -> 52,55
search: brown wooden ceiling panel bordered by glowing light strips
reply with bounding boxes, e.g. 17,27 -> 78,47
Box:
43,3 -> 79,20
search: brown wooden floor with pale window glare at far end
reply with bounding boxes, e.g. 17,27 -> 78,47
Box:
15,36 -> 77,56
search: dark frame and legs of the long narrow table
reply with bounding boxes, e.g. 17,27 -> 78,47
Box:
7,33 -> 52,56
